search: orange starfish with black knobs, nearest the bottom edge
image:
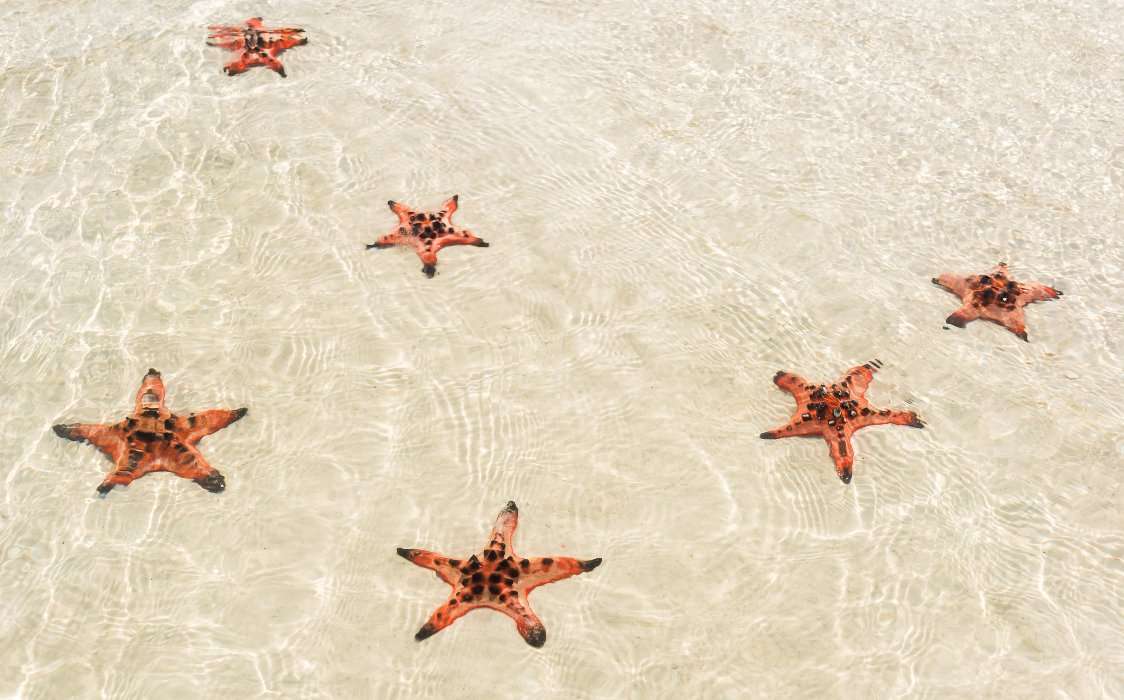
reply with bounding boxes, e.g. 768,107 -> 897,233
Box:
398,501 -> 601,646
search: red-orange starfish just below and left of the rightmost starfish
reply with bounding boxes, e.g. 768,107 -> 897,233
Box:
761,360 -> 925,483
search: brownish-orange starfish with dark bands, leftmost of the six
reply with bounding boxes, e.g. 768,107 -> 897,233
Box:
54,370 -> 246,496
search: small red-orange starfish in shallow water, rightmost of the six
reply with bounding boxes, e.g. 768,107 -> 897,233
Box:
933,263 -> 1061,343
